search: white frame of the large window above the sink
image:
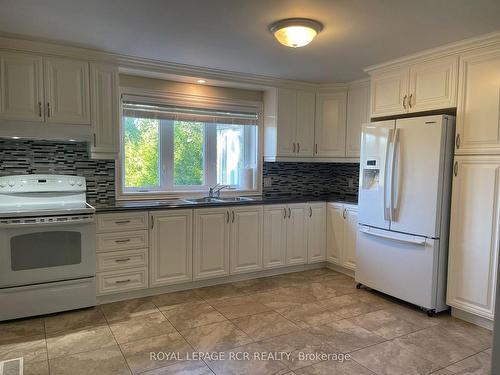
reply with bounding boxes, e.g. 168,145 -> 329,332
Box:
115,87 -> 264,200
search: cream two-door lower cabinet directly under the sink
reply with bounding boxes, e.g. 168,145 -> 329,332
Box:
193,206 -> 263,280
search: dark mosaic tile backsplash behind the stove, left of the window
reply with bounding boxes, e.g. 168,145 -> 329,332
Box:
0,139 -> 115,204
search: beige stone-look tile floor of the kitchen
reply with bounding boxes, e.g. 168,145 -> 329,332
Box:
0,269 -> 492,375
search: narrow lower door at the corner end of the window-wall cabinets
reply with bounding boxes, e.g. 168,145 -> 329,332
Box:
307,202 -> 326,263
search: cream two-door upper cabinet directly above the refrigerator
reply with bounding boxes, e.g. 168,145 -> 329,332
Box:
371,56 -> 458,117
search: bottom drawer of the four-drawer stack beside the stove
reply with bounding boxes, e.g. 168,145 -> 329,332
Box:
96,267 -> 148,295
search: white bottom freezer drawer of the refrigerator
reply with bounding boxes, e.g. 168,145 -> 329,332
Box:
356,225 -> 447,311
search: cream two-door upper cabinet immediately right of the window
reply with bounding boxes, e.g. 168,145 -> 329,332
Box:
264,88 -> 315,158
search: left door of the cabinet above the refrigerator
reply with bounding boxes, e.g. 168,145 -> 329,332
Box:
370,68 -> 409,117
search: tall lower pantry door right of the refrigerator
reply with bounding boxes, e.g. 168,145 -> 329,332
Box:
447,156 -> 500,319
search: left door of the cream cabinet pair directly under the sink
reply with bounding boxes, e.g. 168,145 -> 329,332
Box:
193,208 -> 230,280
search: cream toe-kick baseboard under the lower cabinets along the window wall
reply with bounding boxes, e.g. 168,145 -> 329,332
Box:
97,262 -> 327,305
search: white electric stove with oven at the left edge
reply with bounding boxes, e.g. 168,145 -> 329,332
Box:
0,175 -> 96,320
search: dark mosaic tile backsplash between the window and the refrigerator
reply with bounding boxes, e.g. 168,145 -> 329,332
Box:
263,162 -> 359,200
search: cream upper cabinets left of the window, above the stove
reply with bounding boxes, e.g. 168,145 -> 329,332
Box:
0,51 -> 120,159
